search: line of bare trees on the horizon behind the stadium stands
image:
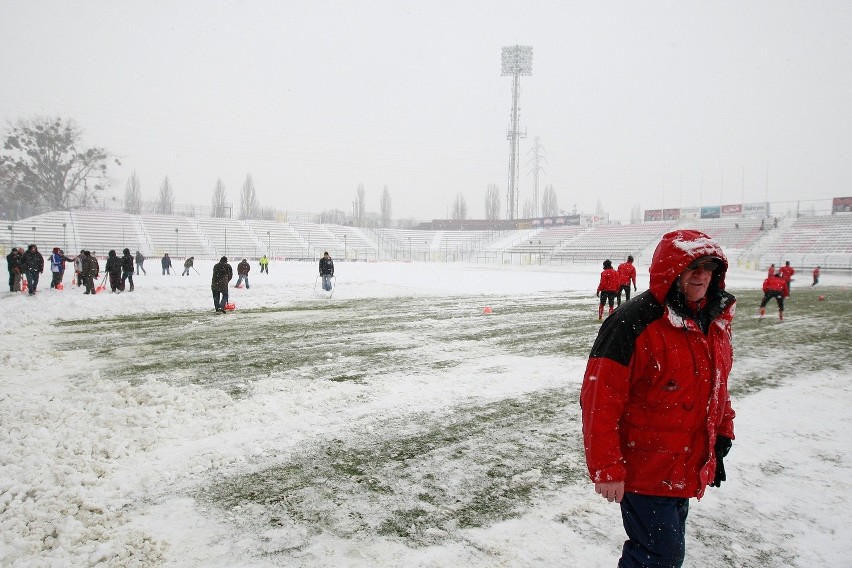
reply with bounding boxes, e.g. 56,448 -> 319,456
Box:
0,117 -> 559,227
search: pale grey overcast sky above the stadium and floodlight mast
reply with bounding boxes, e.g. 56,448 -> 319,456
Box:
0,0 -> 852,219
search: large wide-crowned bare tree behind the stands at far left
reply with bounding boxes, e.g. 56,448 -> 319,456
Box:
0,117 -> 120,209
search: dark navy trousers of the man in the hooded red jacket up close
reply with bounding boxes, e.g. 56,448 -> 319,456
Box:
618,493 -> 689,568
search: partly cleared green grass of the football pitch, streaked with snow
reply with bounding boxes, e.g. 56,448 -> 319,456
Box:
43,287 -> 852,565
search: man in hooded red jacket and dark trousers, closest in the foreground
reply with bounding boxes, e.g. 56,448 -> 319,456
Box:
580,229 -> 735,568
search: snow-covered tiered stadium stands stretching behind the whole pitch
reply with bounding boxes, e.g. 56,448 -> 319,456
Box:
0,209 -> 852,271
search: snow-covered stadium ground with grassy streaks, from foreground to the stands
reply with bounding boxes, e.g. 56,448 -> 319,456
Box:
0,259 -> 852,568
